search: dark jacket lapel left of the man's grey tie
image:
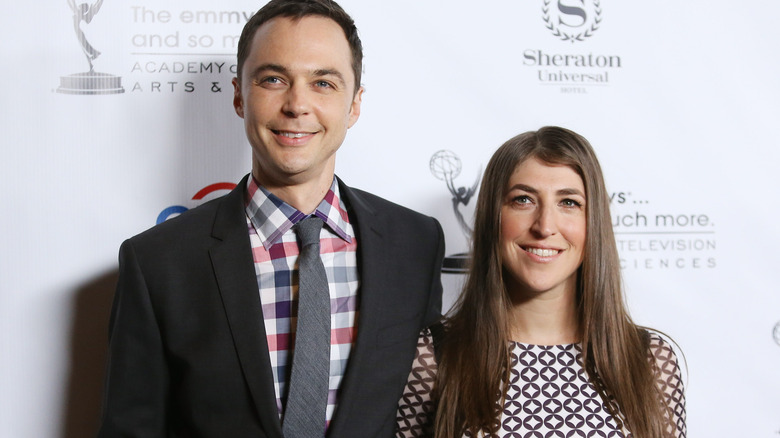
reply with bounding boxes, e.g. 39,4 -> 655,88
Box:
209,177 -> 282,438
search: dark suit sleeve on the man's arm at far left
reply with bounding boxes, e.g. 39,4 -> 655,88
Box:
98,241 -> 169,438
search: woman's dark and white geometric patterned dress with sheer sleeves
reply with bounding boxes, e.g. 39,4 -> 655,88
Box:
396,330 -> 687,438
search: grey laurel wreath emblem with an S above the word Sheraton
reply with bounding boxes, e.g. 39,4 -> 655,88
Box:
542,0 -> 601,44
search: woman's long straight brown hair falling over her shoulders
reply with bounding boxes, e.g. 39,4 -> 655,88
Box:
434,127 -> 672,438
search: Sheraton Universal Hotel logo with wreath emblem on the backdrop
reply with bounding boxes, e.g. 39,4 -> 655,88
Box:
522,0 -> 623,94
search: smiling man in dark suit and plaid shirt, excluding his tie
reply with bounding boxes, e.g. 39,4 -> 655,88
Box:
99,0 -> 444,438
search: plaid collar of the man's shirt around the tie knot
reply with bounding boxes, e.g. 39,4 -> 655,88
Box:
245,177 -> 354,250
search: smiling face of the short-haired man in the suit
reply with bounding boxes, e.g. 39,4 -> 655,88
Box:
233,16 -> 363,188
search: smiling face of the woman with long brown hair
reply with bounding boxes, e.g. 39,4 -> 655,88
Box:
500,158 -> 587,296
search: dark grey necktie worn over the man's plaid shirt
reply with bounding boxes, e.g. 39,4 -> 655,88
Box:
282,216 -> 330,438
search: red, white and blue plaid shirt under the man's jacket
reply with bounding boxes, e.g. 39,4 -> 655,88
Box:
246,178 -> 359,423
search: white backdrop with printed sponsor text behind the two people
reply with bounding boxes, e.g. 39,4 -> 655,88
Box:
0,0 -> 780,438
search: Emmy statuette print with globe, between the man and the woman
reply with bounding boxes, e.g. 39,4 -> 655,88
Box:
430,150 -> 481,274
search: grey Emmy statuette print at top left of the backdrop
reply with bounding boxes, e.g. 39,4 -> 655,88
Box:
57,0 -> 125,94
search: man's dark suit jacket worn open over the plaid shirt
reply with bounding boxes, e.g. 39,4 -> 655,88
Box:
99,178 -> 444,438
